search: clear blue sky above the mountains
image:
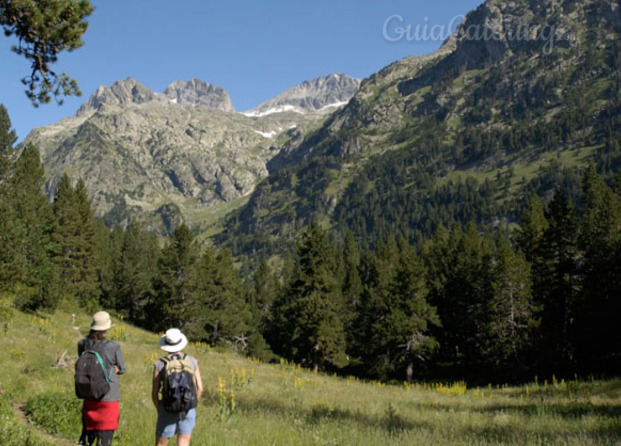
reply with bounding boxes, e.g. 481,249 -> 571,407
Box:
0,0 -> 482,139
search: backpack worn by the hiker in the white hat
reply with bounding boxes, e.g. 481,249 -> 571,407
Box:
160,353 -> 198,414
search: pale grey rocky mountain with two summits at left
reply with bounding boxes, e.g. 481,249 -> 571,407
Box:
27,74 -> 358,232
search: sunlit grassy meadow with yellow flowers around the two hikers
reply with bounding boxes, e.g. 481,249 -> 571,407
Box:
0,299 -> 621,446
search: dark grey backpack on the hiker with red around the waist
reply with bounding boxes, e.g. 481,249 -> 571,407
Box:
74,340 -> 110,400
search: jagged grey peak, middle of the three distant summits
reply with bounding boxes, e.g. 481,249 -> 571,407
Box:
164,79 -> 235,112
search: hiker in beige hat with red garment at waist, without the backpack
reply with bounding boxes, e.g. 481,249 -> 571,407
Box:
78,311 -> 125,446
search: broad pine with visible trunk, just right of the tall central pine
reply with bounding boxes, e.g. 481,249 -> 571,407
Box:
351,236 -> 440,380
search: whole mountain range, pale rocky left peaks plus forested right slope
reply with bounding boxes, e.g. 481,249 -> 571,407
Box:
26,0 -> 621,247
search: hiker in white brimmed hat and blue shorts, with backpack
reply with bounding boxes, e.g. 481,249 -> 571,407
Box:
151,328 -> 203,446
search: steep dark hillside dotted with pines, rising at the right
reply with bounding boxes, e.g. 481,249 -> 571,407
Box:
220,0 -> 621,256
